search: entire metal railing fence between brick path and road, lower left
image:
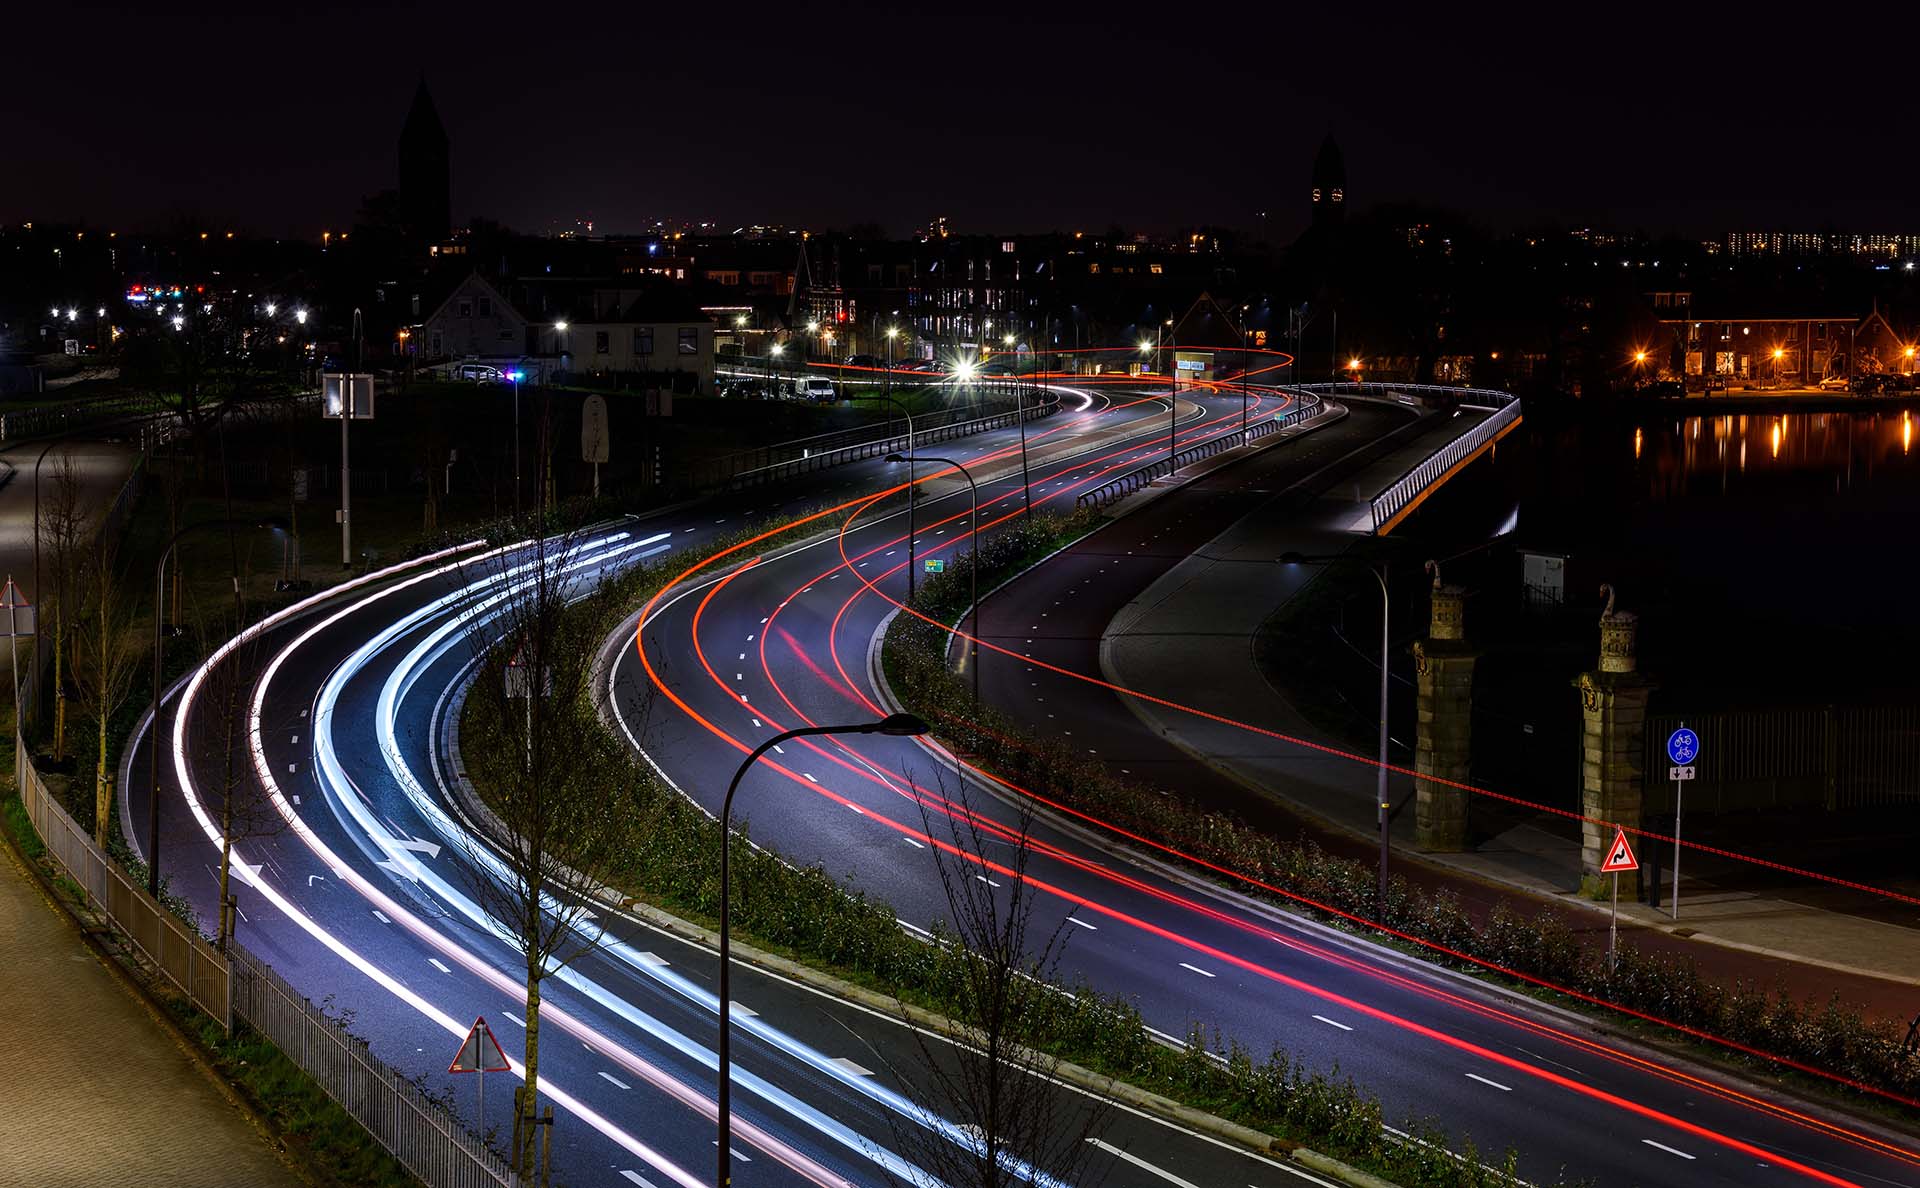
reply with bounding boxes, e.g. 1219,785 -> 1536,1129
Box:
13,745 -> 520,1188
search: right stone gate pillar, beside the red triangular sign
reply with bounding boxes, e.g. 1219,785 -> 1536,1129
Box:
1574,591 -> 1655,900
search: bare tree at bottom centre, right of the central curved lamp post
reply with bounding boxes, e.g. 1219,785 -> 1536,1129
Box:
893,787 -> 1110,1188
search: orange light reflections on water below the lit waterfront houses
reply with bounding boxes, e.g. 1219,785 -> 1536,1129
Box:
1622,413 -> 1920,499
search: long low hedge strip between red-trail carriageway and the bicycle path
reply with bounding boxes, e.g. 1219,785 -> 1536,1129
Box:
881,516 -> 1920,1105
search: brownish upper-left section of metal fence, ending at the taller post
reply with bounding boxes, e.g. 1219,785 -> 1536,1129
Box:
13,739 -> 232,1031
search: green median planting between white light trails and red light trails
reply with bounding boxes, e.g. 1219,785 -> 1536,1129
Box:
522,514 -> 1559,1188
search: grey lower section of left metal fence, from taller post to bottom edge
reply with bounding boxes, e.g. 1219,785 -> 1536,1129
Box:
230,944 -> 518,1188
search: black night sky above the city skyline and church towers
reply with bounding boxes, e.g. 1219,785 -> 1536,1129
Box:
15,2 -> 1920,238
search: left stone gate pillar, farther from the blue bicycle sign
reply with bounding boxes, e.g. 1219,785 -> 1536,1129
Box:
1413,576 -> 1480,852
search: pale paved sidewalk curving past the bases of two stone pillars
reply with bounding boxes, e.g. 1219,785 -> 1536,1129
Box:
1100,416 -> 1920,1019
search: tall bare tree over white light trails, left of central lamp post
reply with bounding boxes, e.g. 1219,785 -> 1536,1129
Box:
449,535 -> 645,1175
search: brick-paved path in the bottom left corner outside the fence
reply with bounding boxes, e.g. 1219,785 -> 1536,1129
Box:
0,843 -> 303,1188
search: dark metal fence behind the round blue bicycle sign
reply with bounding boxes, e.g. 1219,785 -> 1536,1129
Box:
1642,704 -> 1920,814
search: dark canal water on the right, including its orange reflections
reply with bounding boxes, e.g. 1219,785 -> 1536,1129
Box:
1402,407 -> 1920,708
